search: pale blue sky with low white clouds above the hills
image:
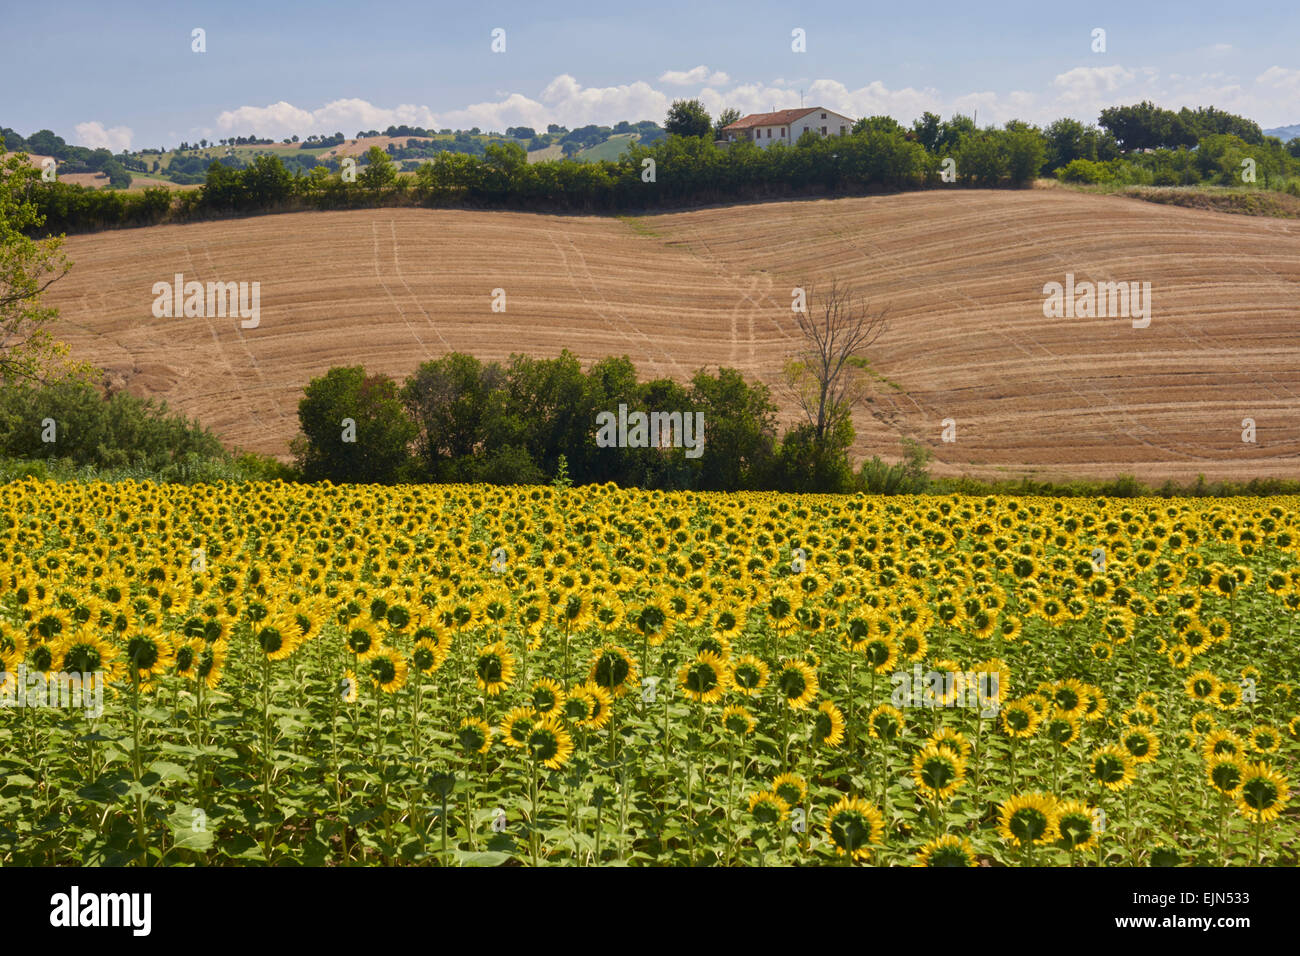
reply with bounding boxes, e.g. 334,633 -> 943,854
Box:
0,0 -> 1300,151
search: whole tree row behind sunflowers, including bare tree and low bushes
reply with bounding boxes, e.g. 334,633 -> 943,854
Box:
293,284 -> 909,492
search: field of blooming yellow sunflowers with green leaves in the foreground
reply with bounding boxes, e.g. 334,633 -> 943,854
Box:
0,480 -> 1300,866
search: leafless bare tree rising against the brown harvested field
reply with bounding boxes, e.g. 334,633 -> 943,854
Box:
785,280 -> 889,445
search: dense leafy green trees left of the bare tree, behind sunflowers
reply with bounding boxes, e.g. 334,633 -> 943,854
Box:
293,351 -> 805,490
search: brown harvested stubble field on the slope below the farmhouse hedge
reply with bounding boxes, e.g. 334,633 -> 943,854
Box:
40,190 -> 1300,480
